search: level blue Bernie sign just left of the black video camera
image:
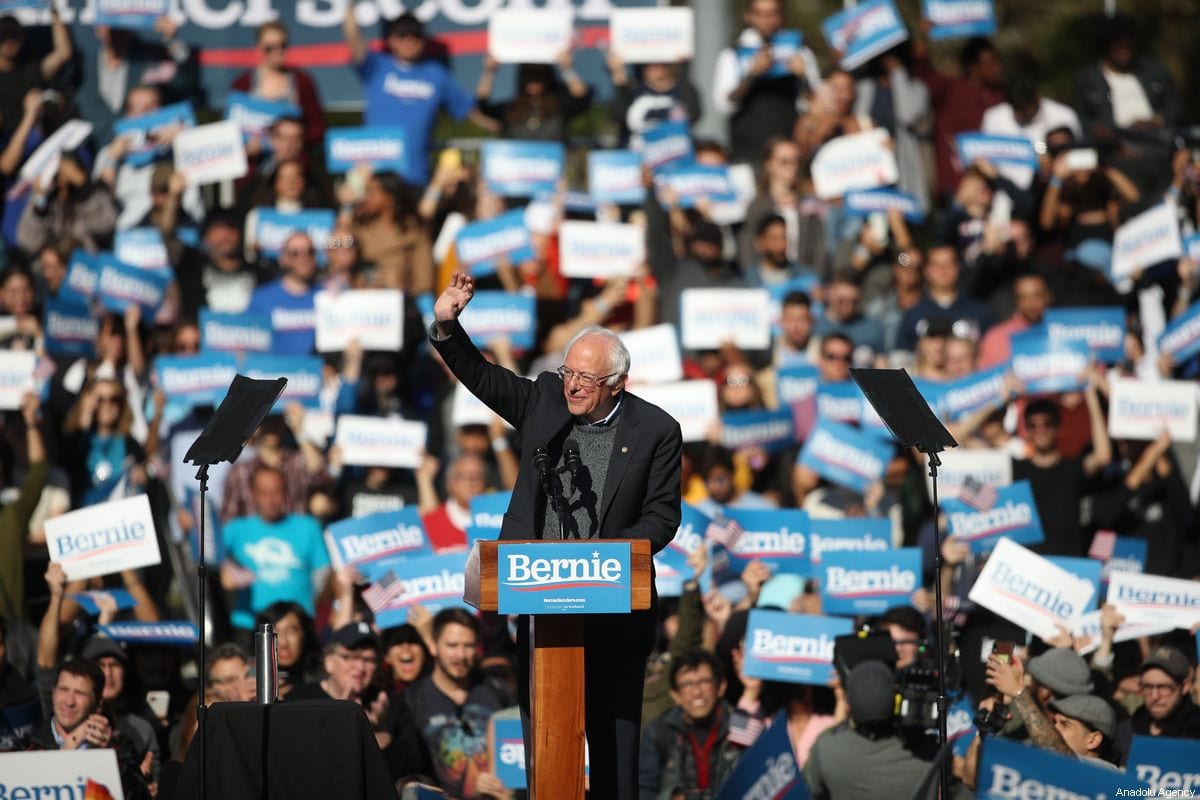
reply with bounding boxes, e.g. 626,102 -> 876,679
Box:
742,608 -> 854,686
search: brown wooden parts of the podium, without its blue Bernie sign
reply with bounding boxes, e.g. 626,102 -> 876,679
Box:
463,539 -> 652,800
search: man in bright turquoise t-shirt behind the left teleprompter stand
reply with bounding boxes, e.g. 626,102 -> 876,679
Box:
221,467 -> 329,630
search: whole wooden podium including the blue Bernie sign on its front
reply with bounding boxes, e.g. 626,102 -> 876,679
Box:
463,539 -> 653,800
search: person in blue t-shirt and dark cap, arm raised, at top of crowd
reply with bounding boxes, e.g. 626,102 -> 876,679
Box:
342,12 -> 484,186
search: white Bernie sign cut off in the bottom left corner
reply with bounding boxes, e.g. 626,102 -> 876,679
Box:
0,753 -> 126,800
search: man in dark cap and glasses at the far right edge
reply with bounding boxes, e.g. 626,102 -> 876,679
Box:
1133,646 -> 1200,739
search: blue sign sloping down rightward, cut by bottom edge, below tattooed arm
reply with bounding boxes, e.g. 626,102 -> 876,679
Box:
976,736 -> 1151,800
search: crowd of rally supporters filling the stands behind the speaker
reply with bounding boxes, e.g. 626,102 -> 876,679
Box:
0,0 -> 1200,800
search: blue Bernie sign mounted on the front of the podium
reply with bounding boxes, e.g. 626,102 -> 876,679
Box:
497,540 -> 630,614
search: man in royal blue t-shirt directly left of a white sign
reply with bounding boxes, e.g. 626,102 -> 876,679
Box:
246,231 -> 317,355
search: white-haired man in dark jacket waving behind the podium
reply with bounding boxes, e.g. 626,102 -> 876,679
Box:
430,273 -> 683,800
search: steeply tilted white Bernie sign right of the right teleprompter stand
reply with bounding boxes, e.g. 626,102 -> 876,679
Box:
968,539 -> 1111,639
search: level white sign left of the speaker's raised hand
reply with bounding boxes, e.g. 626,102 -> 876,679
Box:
313,289 -> 404,353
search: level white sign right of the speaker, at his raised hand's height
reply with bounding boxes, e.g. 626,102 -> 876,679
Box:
679,289 -> 770,350
